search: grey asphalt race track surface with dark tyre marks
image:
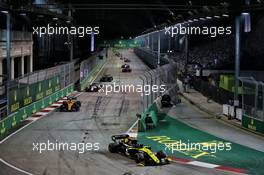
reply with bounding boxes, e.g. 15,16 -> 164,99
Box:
0,50 -> 241,175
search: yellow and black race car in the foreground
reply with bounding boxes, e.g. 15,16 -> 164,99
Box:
108,134 -> 170,166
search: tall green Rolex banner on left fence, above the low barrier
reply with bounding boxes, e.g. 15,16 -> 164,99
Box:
9,76 -> 61,114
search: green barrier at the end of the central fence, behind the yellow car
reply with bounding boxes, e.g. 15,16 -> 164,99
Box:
139,102 -> 166,131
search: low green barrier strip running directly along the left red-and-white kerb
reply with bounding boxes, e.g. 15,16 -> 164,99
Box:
0,84 -> 73,136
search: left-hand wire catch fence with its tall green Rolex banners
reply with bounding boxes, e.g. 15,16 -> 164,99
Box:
0,63 -> 74,119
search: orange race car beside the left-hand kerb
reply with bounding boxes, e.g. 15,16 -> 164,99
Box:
60,97 -> 81,112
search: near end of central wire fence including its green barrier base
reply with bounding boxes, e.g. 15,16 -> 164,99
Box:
139,63 -> 179,131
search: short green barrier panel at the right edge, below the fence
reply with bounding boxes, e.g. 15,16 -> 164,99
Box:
242,114 -> 264,134
